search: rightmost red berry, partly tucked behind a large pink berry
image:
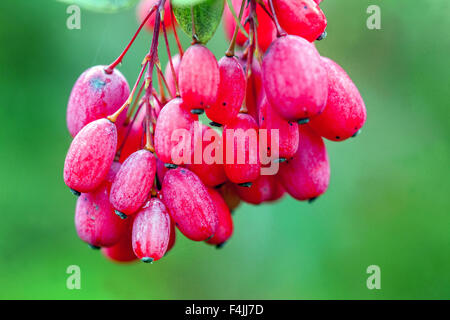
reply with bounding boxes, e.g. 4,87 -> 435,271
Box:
310,58 -> 367,141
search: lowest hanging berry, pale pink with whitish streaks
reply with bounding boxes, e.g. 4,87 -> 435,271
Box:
132,198 -> 171,262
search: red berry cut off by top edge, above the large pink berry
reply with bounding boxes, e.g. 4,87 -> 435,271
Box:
273,0 -> 327,42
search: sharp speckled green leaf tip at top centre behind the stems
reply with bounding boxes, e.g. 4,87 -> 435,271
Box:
172,0 -> 225,43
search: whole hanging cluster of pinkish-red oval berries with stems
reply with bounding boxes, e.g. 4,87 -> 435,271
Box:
64,0 -> 366,262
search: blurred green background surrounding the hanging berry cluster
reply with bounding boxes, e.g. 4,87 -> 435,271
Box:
0,0 -> 450,299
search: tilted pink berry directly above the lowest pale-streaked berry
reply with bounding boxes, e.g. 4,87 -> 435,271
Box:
109,149 -> 156,215
